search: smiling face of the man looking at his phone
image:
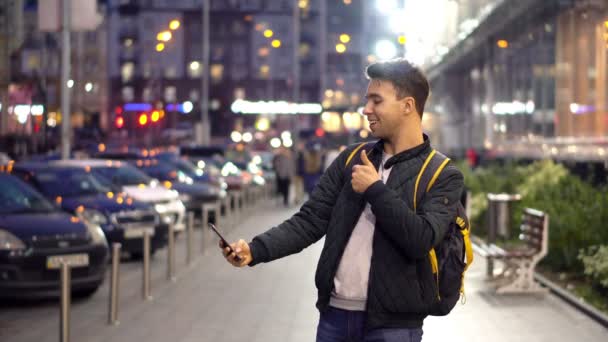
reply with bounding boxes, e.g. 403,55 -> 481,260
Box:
363,80 -> 412,140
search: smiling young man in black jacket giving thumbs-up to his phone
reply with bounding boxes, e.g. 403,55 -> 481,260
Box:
224,59 -> 463,342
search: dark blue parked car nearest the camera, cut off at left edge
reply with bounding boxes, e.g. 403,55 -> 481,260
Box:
0,173 -> 108,298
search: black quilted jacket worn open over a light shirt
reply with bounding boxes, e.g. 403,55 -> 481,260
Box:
250,135 -> 463,329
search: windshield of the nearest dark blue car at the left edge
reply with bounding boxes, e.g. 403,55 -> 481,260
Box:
0,174 -> 55,214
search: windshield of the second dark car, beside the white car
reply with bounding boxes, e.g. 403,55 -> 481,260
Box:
35,169 -> 110,197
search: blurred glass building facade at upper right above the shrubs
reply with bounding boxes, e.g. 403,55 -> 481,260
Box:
427,0 -> 608,160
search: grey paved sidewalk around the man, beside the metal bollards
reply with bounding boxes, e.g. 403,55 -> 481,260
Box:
0,199 -> 608,342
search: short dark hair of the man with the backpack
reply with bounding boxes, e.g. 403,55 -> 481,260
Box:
365,58 -> 430,118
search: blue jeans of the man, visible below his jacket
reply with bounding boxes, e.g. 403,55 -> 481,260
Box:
317,307 -> 422,342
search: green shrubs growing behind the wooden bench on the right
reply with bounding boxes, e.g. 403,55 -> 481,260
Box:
459,160 -> 608,274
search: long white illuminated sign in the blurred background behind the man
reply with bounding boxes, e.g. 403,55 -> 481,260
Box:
230,100 -> 323,114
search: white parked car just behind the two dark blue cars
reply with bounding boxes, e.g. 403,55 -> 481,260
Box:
50,159 -> 186,231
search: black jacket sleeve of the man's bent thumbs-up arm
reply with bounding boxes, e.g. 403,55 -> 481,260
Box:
364,165 -> 464,259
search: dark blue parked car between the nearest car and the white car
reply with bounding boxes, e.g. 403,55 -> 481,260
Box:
12,162 -> 167,257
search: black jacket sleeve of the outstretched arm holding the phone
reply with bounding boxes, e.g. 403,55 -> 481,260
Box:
249,149 -> 350,266
